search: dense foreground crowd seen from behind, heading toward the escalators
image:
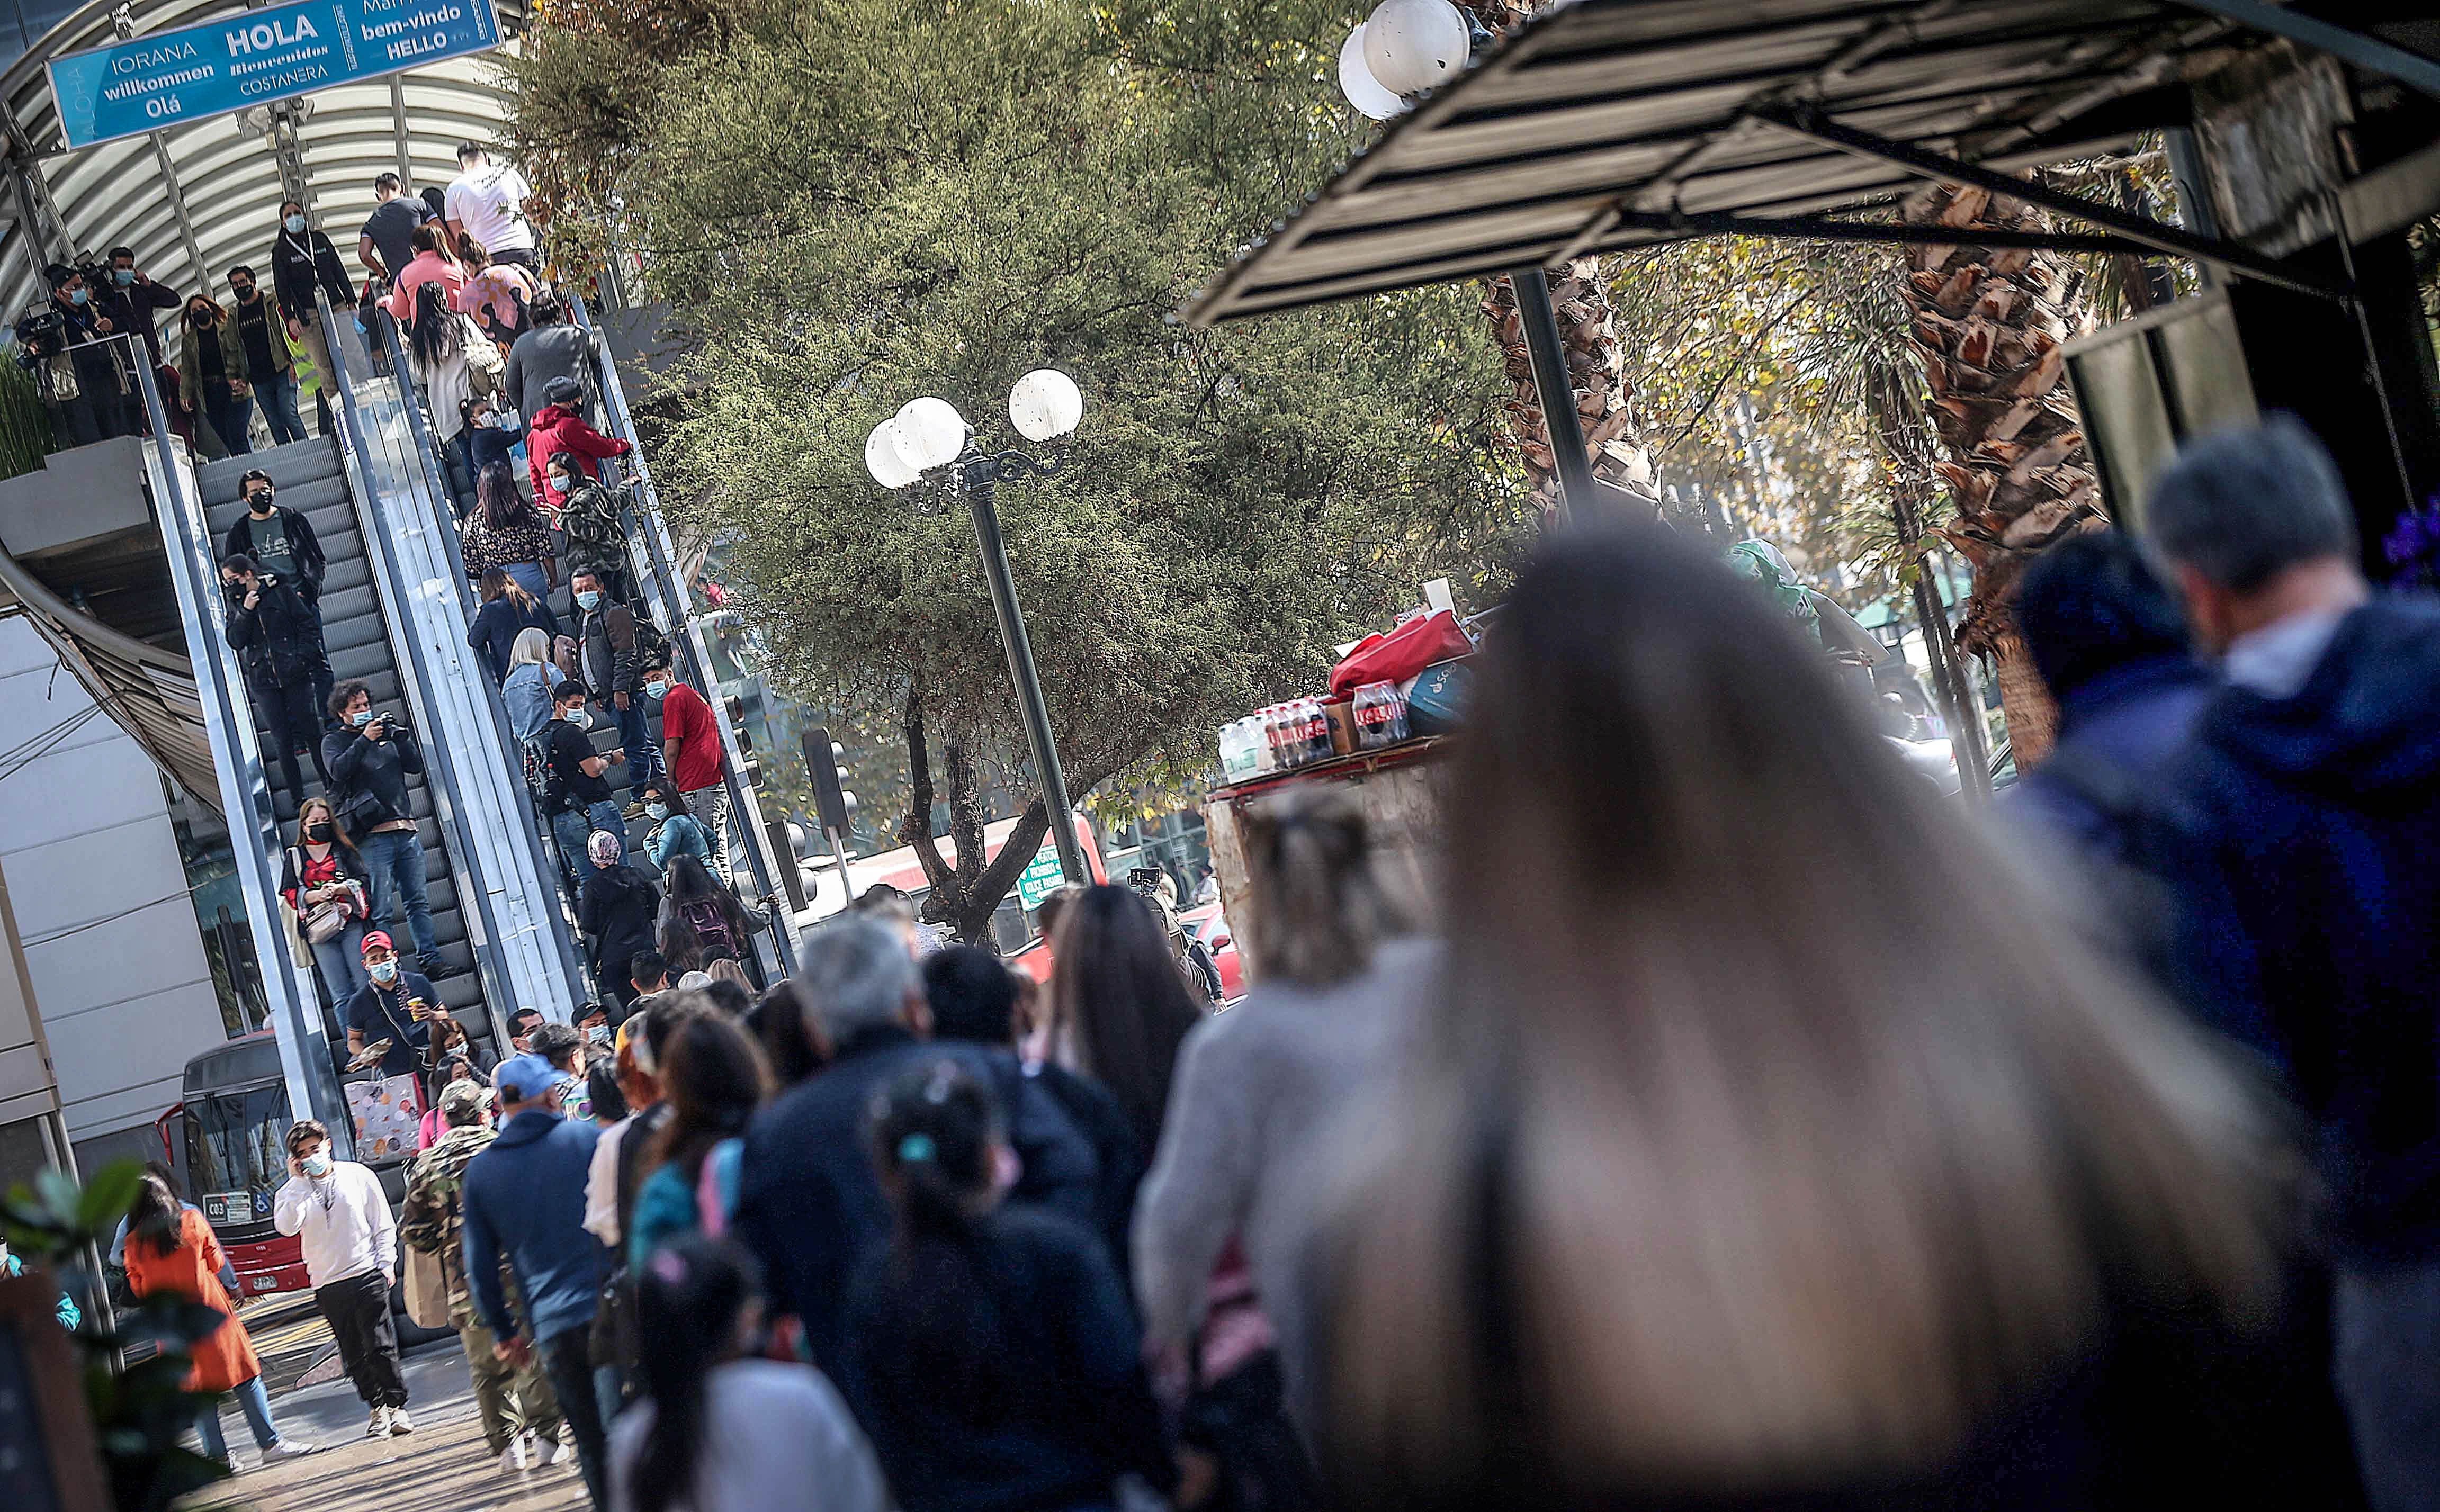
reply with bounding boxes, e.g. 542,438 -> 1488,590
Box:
224,422 -> 2440,1512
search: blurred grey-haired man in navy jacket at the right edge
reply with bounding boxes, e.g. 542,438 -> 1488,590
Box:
2145,417 -> 2440,1512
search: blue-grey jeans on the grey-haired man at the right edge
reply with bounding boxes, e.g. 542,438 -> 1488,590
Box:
2330,1261 -> 2440,1512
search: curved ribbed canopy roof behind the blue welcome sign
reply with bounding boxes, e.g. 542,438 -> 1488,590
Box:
0,0 -> 525,327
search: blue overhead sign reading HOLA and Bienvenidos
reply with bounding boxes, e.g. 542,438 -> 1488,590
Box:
51,0 -> 500,146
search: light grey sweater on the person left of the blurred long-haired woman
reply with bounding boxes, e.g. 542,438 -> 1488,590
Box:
1132,939 -> 1440,1400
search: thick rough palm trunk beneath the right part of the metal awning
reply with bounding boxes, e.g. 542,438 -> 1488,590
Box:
1898,183 -> 2106,768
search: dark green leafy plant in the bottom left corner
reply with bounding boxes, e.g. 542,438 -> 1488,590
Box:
0,1161 -> 229,1512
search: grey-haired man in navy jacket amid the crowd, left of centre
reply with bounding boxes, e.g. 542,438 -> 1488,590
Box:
734,917 -> 1100,1373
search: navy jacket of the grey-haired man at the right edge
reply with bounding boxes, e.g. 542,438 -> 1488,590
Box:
2172,595 -> 2440,1261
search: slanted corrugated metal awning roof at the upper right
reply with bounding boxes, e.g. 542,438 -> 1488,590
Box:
1186,0 -> 2238,325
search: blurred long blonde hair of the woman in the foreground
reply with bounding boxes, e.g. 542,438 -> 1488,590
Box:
1310,532 -> 2294,1507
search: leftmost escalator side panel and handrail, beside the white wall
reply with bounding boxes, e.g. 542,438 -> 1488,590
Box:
137,351 -> 356,1154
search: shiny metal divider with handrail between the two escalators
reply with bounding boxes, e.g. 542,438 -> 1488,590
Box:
315,290 -> 569,1046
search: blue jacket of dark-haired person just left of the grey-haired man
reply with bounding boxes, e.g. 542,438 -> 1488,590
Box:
2008,656 -> 2220,861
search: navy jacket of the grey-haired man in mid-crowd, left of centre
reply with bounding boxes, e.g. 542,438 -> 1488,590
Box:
727,1029 -> 1100,1375
